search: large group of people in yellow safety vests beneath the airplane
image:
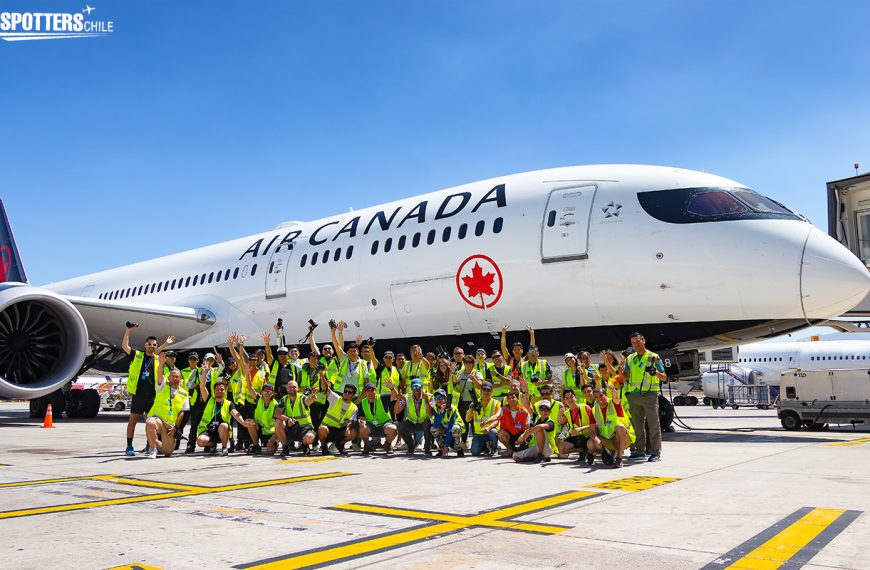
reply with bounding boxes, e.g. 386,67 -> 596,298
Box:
121,321 -> 667,468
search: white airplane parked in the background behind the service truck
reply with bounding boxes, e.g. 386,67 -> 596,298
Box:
702,340 -> 870,401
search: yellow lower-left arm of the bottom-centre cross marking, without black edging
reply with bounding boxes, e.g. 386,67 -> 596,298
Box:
247,523 -> 468,569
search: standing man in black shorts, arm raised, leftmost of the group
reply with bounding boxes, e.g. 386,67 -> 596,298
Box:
121,323 -> 175,455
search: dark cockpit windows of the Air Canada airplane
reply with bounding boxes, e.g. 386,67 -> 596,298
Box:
637,188 -> 800,224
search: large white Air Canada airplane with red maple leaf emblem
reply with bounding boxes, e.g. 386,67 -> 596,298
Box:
0,165 -> 870,415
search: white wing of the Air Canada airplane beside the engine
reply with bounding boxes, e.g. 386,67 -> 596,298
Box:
65,296 -> 215,345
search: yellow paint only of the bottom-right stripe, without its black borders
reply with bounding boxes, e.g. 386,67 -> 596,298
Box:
729,509 -> 846,570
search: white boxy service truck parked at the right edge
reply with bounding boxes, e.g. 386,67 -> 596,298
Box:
777,369 -> 870,430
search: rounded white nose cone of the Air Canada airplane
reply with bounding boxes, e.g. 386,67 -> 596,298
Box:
801,227 -> 870,320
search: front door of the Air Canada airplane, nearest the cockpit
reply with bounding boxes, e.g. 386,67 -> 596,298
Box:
541,184 -> 598,263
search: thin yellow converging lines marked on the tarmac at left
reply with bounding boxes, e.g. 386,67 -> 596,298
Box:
0,471 -> 356,520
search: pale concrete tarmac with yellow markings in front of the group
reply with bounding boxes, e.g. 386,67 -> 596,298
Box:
0,403 -> 870,570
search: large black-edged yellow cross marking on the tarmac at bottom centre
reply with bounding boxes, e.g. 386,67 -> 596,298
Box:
236,491 -> 601,569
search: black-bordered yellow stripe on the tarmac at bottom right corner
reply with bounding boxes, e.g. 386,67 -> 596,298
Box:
701,507 -> 862,570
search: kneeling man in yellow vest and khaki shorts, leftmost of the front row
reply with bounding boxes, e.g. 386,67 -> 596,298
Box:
145,353 -> 190,459
